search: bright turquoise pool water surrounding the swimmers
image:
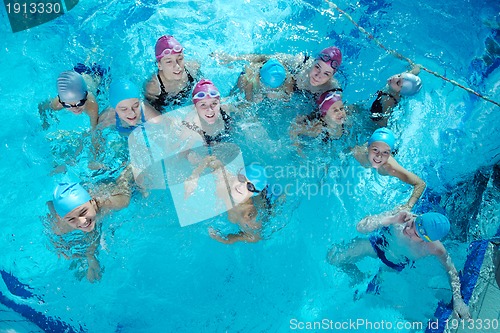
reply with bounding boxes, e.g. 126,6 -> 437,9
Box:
0,0 -> 500,332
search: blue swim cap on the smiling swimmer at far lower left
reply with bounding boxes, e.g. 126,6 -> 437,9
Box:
52,183 -> 92,217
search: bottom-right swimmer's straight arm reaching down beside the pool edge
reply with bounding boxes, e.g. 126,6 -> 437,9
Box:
429,241 -> 471,319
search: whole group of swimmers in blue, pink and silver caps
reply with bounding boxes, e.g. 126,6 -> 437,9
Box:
40,36 -> 469,318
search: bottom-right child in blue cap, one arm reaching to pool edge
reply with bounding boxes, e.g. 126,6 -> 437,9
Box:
327,211 -> 470,319
